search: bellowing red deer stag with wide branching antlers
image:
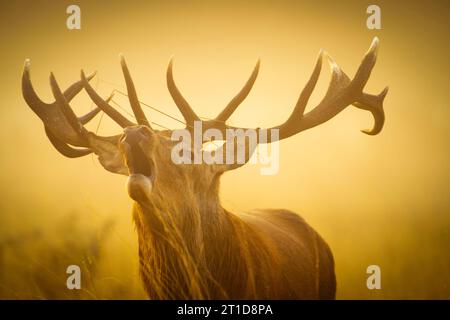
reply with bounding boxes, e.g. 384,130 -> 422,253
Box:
22,38 -> 387,299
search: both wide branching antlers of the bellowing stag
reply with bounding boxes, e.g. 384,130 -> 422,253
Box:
22,37 -> 388,174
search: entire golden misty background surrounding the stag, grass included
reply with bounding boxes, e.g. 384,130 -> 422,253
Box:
0,1 -> 450,299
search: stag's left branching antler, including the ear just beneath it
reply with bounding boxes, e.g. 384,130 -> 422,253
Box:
22,56 -> 150,175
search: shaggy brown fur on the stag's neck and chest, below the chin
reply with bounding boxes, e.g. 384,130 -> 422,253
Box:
134,172 -> 274,299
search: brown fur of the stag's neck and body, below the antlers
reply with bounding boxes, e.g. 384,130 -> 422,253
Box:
125,131 -> 336,299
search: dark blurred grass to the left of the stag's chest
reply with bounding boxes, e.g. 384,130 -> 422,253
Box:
0,213 -> 145,299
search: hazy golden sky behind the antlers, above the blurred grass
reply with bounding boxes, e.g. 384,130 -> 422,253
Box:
0,0 -> 450,298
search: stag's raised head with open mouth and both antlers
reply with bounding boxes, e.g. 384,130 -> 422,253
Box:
22,38 -> 387,208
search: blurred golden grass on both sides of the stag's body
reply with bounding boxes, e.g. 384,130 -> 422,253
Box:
0,206 -> 450,299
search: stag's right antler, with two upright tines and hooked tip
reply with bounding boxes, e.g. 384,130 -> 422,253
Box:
167,37 -> 388,143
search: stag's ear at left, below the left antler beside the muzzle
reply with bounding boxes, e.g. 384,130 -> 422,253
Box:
87,132 -> 128,176
